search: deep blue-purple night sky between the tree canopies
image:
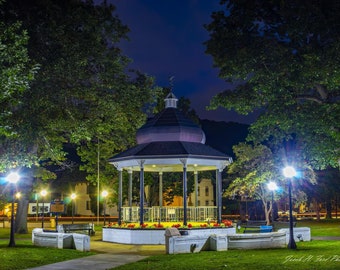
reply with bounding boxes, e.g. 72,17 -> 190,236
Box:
108,0 -> 253,123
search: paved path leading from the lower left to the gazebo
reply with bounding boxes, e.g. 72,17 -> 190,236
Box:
25,236 -> 340,270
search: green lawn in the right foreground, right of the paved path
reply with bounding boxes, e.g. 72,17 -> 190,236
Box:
114,241 -> 340,270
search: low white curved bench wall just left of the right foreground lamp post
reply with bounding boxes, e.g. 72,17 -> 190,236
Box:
227,231 -> 286,249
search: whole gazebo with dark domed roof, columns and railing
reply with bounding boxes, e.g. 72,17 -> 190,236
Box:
109,92 -> 232,226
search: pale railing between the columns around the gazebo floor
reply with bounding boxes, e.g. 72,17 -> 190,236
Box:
122,206 -> 217,222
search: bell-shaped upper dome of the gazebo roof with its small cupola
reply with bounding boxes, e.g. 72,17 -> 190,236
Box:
136,93 -> 205,144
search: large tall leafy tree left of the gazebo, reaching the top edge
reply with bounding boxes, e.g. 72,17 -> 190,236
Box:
0,0 -> 158,230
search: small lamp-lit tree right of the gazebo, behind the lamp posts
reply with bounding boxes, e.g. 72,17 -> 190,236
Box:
225,143 -> 315,224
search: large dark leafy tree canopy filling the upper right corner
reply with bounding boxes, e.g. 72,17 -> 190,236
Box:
205,0 -> 340,169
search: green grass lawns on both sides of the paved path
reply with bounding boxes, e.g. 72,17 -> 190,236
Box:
0,220 -> 340,270
